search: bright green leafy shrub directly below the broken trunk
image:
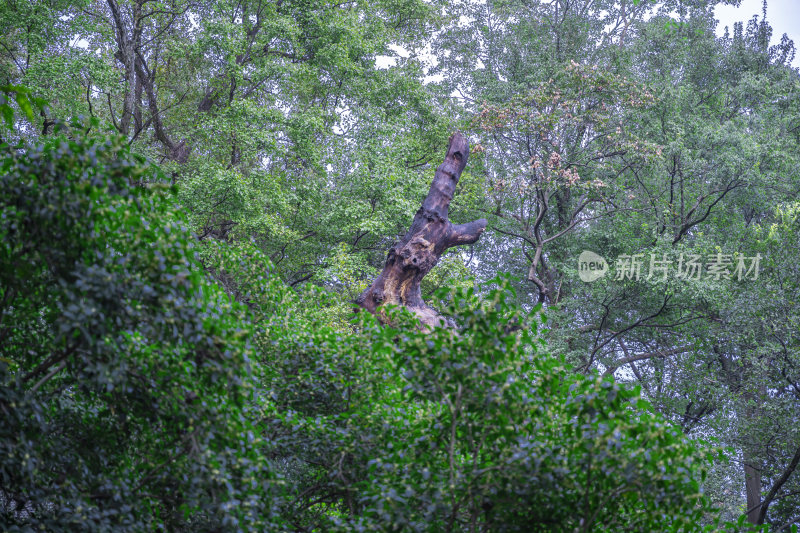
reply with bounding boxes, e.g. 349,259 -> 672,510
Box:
209,232 -> 712,531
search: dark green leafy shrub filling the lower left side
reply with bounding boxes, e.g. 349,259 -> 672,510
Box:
0,131 -> 276,531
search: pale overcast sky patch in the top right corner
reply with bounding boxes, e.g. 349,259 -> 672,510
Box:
714,0 -> 800,67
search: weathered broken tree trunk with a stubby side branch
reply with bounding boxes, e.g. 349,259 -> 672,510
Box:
356,133 -> 486,328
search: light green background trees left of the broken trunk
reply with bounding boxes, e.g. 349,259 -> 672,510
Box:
0,0 -> 460,300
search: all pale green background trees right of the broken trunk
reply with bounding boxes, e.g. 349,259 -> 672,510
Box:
434,1 -> 800,527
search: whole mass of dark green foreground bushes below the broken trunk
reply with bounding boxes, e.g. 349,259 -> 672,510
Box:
0,123 -> 711,531
